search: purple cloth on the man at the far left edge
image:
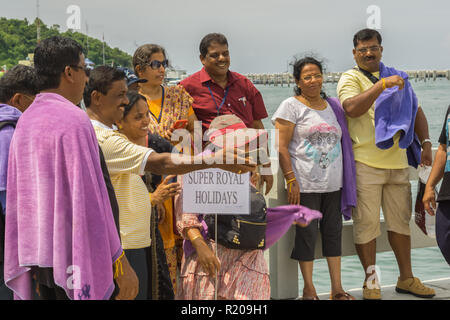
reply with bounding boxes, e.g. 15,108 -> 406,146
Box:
0,104 -> 22,191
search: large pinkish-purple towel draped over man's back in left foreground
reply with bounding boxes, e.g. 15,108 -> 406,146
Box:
4,93 -> 122,300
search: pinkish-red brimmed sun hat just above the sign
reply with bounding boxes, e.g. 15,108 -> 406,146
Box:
206,114 -> 267,148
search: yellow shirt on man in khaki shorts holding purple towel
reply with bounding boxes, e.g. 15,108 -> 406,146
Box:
337,69 -> 408,169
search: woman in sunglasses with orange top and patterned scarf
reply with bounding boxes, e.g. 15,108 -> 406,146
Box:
133,44 -> 201,288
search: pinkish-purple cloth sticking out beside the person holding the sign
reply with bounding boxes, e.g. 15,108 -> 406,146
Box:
183,205 -> 322,257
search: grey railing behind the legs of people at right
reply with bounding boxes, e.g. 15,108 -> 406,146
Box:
266,149 -> 437,299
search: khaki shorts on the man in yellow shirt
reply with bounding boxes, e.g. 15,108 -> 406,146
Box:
352,162 -> 412,244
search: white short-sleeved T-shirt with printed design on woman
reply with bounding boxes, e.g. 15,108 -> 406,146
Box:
272,97 -> 343,193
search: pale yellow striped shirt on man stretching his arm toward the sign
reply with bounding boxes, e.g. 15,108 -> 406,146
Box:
94,123 -> 153,249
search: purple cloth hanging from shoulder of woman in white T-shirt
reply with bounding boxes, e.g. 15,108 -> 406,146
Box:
327,98 -> 357,220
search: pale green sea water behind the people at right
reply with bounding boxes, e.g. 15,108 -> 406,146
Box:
256,79 -> 450,295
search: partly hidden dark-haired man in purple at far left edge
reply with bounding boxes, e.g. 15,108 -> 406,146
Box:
0,65 -> 37,300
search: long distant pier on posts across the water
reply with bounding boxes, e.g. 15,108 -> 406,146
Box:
245,70 -> 450,86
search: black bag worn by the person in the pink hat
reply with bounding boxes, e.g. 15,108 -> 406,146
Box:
203,186 -> 267,250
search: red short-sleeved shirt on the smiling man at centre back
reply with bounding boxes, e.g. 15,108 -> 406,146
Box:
180,68 -> 267,131
